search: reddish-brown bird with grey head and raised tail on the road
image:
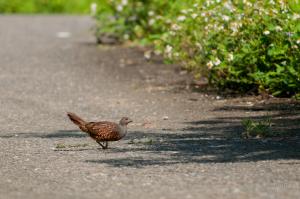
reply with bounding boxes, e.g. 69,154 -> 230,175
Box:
67,112 -> 132,149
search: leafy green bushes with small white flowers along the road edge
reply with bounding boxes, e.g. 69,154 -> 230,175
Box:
98,0 -> 300,97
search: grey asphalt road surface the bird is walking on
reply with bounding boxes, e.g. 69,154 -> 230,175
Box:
0,16 -> 300,199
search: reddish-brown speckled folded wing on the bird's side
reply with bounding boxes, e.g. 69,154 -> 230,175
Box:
86,121 -> 120,141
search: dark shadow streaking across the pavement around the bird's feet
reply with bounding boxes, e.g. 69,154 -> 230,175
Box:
0,99 -> 300,168
